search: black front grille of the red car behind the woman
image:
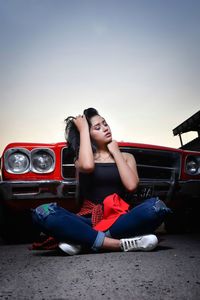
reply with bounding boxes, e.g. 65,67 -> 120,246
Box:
62,147 -> 181,205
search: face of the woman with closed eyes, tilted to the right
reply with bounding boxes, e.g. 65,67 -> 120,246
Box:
90,115 -> 112,145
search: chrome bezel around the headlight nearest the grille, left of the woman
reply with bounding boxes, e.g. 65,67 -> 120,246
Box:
31,148 -> 56,174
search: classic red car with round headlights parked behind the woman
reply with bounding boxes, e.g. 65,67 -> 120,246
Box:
0,142 -> 200,241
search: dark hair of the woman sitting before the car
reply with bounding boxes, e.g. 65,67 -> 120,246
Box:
65,108 -> 99,160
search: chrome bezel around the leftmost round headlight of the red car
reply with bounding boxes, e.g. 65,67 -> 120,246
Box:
4,148 -> 31,174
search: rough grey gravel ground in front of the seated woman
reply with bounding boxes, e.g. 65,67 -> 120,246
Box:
0,234 -> 200,300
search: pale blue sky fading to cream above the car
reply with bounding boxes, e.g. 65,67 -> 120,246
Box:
0,0 -> 200,156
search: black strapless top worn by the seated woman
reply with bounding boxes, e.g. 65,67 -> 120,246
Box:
79,163 -> 125,204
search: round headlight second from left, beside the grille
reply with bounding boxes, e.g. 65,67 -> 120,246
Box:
31,149 -> 54,173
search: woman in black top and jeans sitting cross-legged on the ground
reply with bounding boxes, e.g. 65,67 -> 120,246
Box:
33,108 -> 170,255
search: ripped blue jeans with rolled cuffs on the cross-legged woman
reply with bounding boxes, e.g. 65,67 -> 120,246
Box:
32,198 -> 171,251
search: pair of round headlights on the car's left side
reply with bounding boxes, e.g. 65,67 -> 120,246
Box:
4,148 -> 55,174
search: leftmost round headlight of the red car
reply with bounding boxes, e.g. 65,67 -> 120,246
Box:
6,152 -> 30,174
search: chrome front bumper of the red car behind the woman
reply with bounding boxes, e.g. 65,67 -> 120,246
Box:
0,180 -> 200,202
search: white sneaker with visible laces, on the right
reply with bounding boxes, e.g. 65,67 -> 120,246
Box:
120,234 -> 158,252
